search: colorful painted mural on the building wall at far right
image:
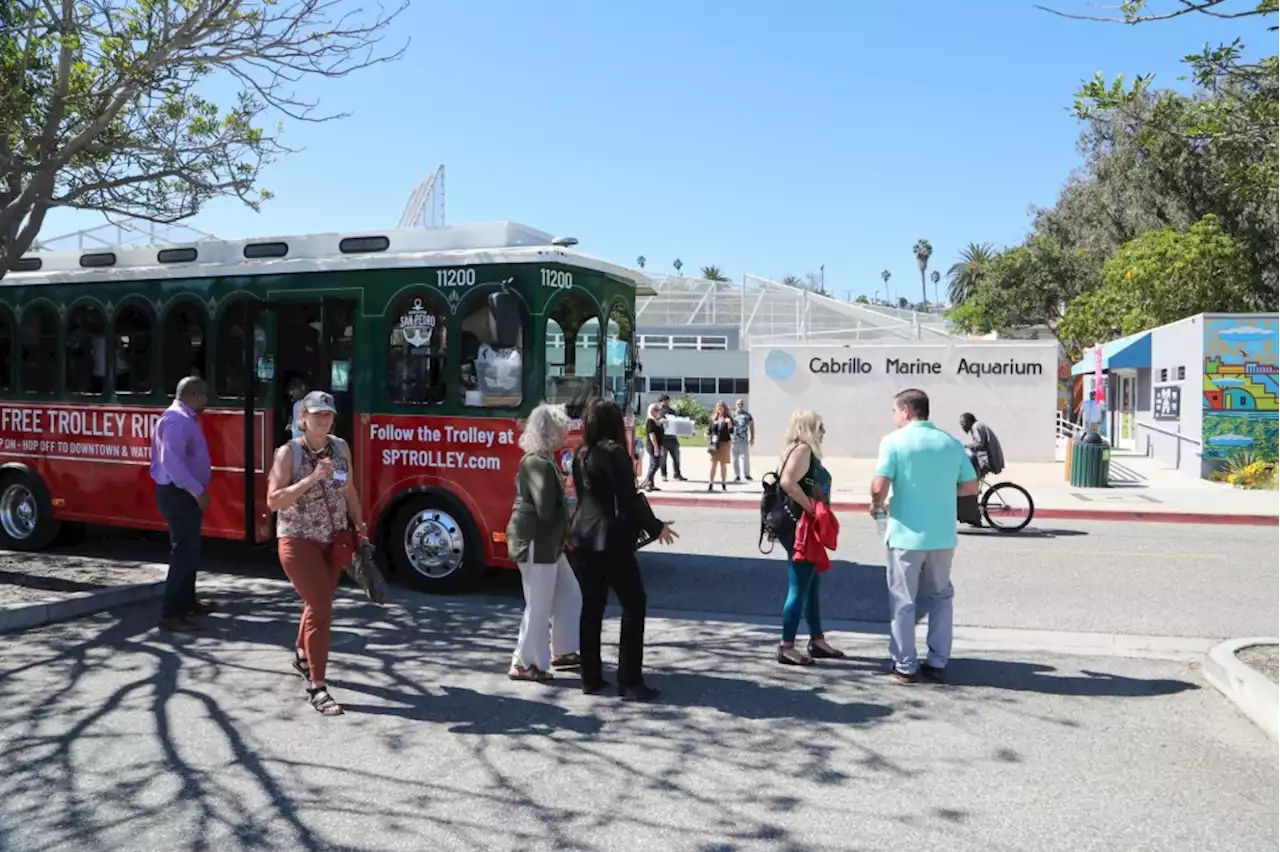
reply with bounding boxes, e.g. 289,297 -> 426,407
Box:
1202,316 -> 1280,461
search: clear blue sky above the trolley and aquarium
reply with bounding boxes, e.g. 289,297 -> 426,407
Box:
45,0 -> 1265,299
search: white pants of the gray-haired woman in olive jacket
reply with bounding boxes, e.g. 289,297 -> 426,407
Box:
511,546 -> 582,672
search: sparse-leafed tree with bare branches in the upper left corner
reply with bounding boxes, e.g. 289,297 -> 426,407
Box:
0,0 -> 404,276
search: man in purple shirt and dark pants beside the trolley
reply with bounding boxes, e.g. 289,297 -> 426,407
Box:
151,376 -> 215,633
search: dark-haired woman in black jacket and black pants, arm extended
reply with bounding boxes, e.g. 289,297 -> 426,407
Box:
572,399 -> 676,701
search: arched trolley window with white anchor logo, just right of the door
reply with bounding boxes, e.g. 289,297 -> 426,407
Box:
387,290 -> 449,406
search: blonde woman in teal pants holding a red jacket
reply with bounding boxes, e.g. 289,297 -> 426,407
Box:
778,411 -> 845,665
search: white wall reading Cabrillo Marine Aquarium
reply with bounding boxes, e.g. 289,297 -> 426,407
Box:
750,342 -> 1057,462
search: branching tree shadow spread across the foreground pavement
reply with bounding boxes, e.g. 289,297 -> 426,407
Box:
0,578 -> 914,852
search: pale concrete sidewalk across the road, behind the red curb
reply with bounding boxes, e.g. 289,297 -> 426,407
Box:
650,450 -> 1280,526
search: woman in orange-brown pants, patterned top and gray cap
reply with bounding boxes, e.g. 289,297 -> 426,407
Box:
266,390 -> 365,716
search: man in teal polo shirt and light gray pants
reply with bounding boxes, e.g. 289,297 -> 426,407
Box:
872,389 -> 978,683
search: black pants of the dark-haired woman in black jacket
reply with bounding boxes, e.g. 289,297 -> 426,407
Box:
579,550 -> 645,687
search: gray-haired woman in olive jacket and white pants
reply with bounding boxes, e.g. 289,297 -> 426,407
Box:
507,406 -> 582,682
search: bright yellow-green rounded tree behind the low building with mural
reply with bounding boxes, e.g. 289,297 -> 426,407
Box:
1060,216 -> 1258,349
